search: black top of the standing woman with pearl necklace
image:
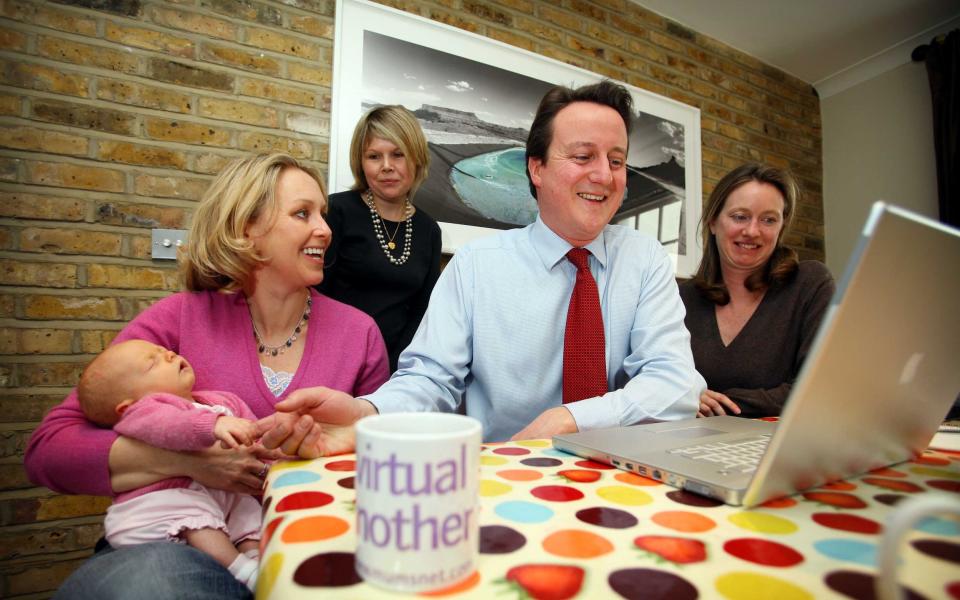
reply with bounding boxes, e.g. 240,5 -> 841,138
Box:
317,191 -> 441,372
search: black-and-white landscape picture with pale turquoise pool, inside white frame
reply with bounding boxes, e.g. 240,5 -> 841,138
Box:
354,30 -> 699,255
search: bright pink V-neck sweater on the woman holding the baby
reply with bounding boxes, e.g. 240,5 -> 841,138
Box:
24,290 -> 389,496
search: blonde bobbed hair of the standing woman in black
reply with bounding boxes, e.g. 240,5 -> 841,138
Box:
350,105 -> 430,201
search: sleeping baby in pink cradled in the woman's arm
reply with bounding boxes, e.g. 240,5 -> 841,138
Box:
77,340 -> 261,590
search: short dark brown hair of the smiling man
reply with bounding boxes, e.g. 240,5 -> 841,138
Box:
524,79 -> 633,198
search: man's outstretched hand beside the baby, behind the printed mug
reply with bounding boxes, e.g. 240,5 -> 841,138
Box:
257,387 -> 377,458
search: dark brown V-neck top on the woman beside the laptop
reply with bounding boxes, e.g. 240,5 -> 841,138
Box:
680,260 -> 834,417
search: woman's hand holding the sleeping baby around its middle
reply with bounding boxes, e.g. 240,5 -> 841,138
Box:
182,444 -> 283,495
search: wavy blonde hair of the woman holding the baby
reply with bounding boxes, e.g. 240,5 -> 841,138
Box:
180,153 -> 326,292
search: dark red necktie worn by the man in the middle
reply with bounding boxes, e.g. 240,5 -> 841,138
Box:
563,248 -> 607,404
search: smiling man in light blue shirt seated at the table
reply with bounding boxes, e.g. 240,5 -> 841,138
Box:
264,81 -> 704,457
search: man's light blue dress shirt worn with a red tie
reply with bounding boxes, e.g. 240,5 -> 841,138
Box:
365,217 -> 705,441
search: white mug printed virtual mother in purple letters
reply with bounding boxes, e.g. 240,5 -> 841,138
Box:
354,413 -> 483,592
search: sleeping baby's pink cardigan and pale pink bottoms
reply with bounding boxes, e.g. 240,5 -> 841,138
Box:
103,391 -> 260,548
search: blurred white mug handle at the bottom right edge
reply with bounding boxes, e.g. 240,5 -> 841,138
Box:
876,494 -> 960,600
